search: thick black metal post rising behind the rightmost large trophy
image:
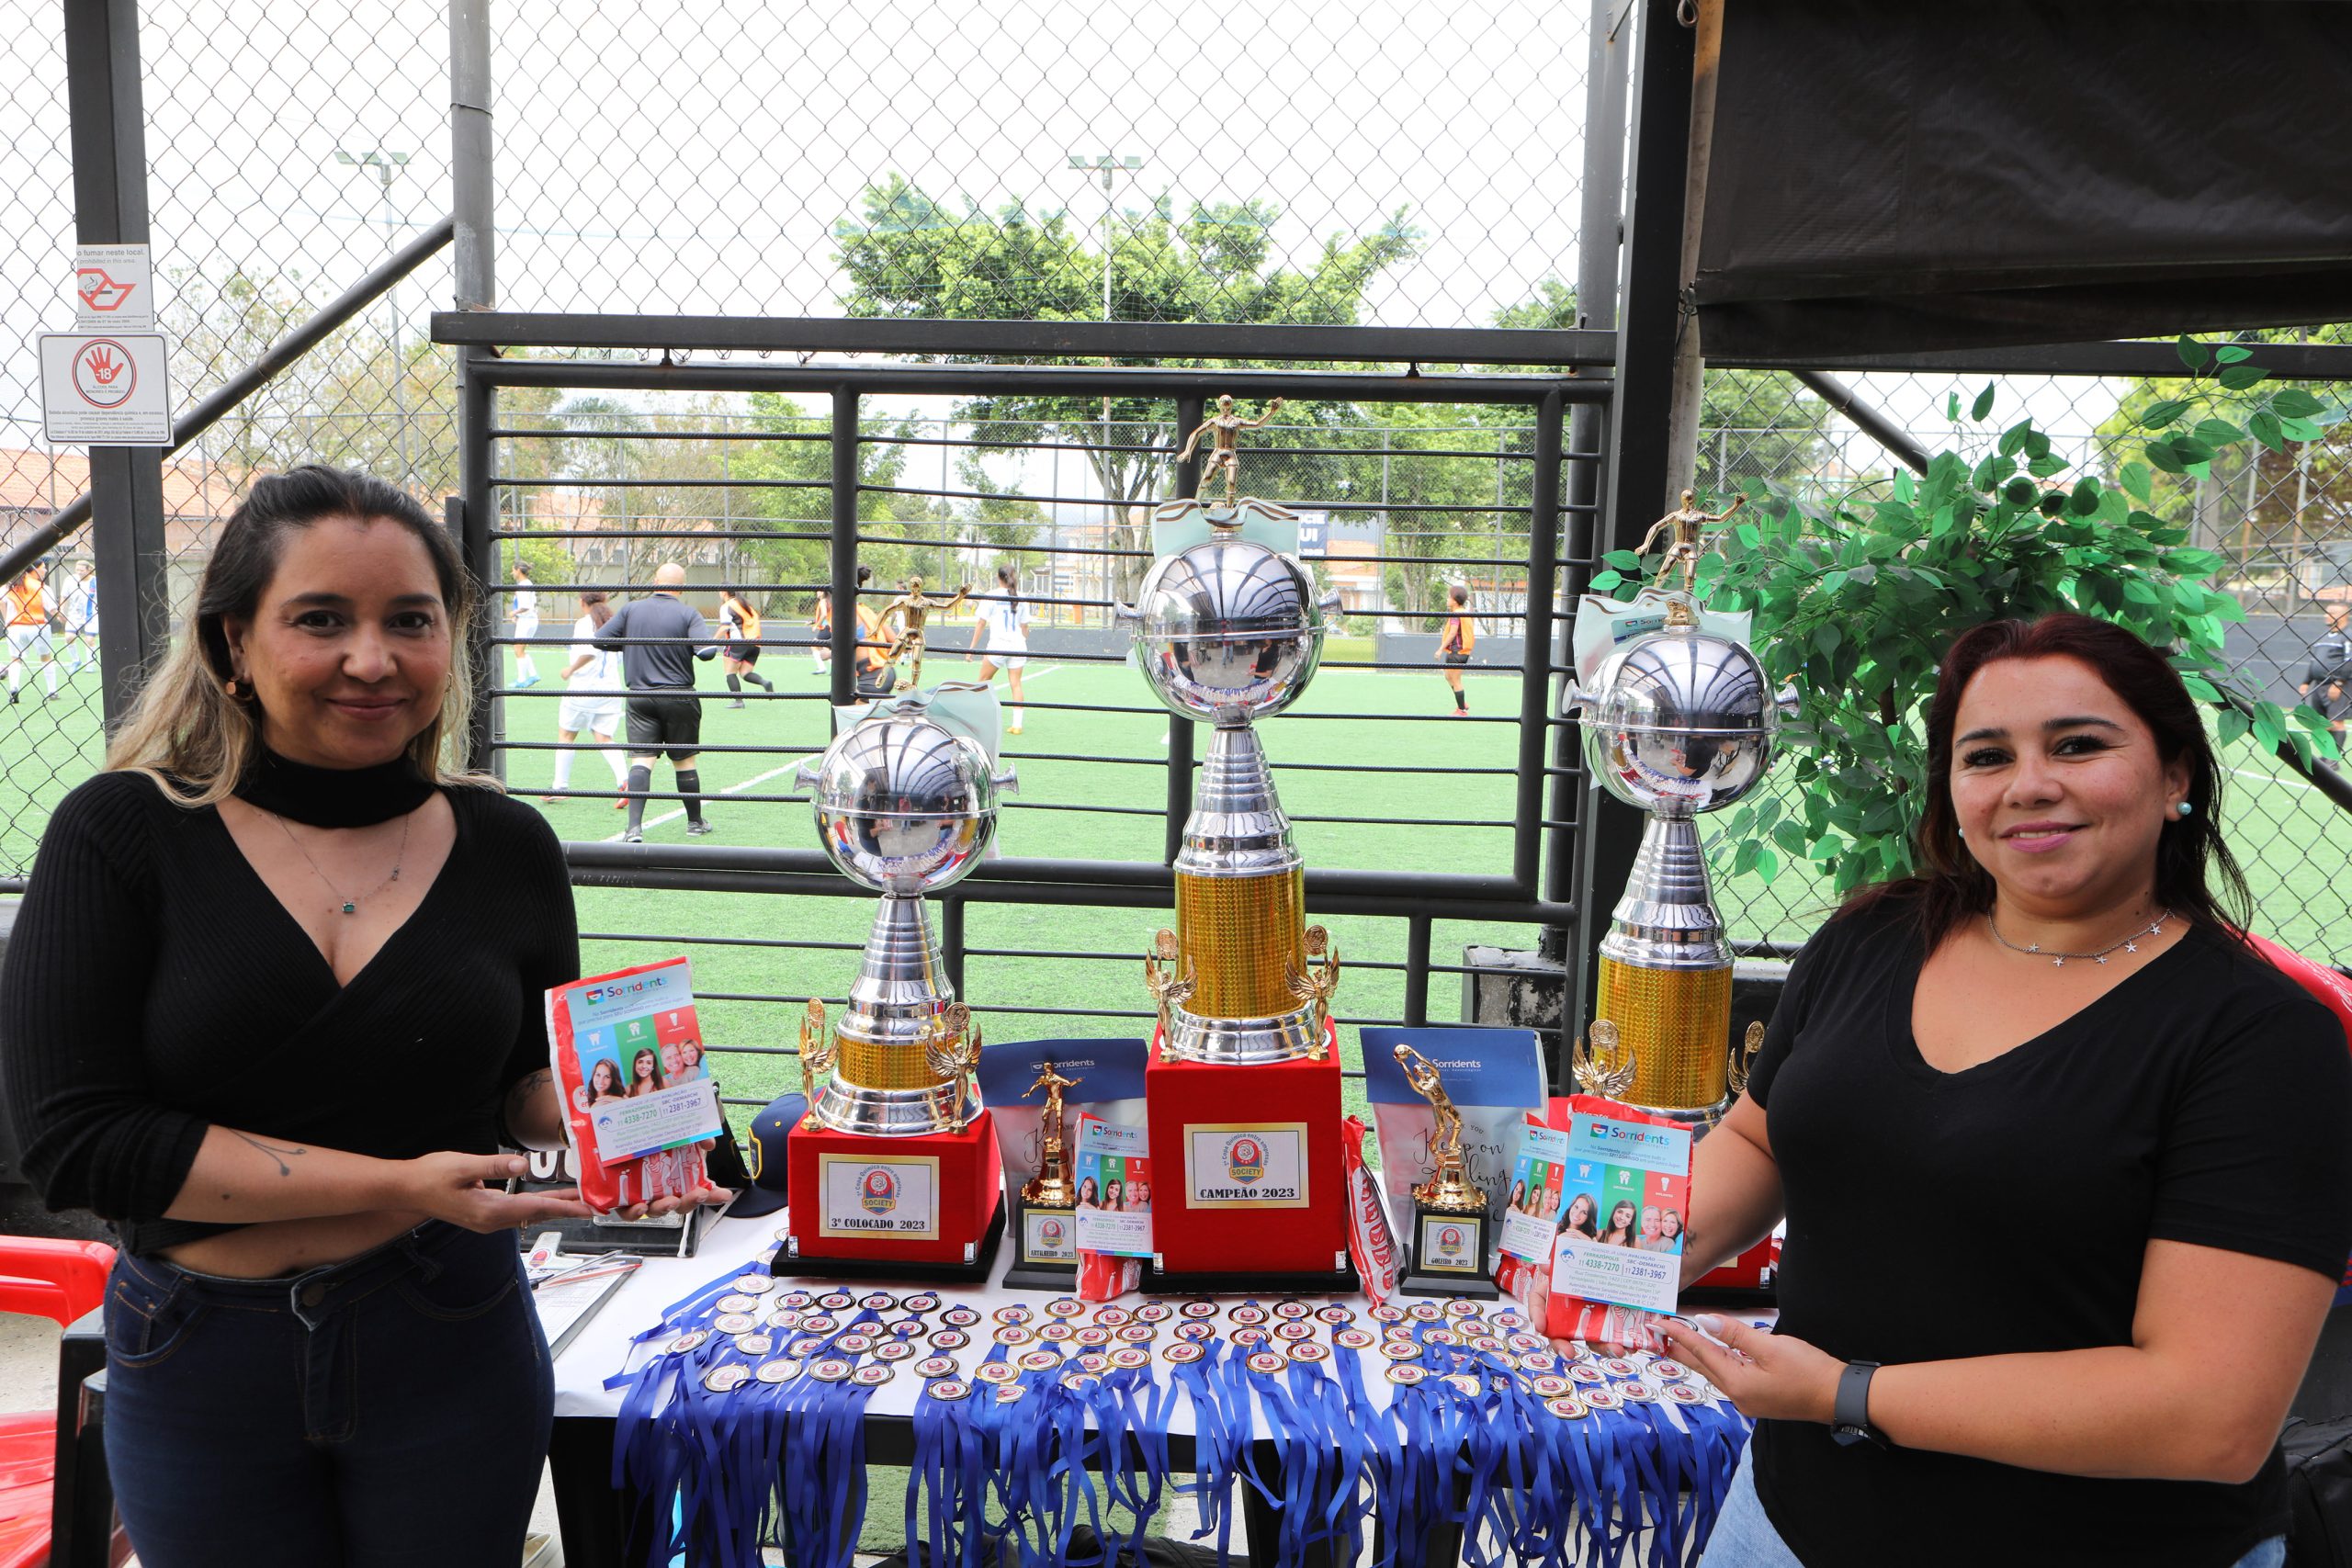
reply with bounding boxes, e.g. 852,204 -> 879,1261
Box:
1562,0 -> 1698,1042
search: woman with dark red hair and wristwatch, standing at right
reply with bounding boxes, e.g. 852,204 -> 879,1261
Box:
1668,614 -> 2352,1568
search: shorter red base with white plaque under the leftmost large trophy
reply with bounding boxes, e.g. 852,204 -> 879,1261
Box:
772,1110 -> 1004,1281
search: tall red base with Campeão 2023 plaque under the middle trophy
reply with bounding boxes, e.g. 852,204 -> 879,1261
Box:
1143,1025 -> 1355,1293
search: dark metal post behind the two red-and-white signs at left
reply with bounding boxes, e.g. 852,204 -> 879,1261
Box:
63,0 -> 172,728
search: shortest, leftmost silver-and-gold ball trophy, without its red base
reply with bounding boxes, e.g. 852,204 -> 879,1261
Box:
799,694 -> 1013,1138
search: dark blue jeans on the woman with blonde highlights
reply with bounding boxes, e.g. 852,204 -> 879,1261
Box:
106,1220 -> 555,1568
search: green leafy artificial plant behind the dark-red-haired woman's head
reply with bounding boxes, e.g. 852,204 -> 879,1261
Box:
1592,339 -> 2345,896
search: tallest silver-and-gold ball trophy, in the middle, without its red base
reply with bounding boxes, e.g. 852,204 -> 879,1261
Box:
1117,501 -> 1339,1063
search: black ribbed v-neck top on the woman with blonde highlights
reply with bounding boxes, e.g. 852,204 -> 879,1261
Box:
0,773 -> 579,1256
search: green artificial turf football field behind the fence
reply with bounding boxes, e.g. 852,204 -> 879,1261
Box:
14,649 -> 2352,1142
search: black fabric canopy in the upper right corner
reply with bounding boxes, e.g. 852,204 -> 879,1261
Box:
1696,0 -> 2352,360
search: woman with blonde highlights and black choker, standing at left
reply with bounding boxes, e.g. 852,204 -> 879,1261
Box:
0,468 -> 715,1568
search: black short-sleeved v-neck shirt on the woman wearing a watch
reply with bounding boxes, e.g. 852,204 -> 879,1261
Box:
1747,898 -> 2352,1568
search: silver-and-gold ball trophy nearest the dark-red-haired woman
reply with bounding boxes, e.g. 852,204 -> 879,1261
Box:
1569,594 -> 1781,1122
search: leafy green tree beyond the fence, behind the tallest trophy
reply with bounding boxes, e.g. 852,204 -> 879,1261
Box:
835,174 -> 1419,592
